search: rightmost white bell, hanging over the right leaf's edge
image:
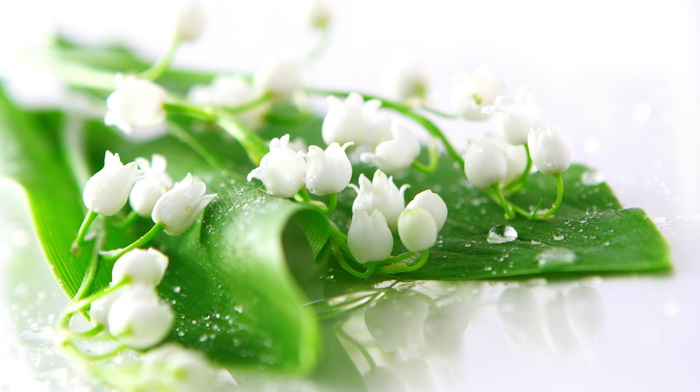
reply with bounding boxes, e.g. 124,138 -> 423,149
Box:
527,123 -> 571,175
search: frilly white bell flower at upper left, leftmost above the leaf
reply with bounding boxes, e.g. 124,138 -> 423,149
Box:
105,74 -> 168,136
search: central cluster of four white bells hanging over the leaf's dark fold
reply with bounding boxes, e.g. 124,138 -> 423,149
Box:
348,170 -> 447,263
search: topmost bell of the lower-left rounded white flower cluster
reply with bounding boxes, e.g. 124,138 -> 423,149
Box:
112,248 -> 168,286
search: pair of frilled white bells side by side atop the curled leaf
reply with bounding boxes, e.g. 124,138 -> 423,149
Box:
248,135 -> 352,198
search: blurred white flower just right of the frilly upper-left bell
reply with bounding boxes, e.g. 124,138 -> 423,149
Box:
187,75 -> 270,129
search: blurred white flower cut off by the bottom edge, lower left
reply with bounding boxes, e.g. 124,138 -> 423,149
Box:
141,343 -> 216,392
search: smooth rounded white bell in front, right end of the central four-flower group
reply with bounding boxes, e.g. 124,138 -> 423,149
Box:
399,208 -> 438,252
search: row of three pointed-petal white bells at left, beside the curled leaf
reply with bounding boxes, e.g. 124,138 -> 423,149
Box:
83,151 -> 216,235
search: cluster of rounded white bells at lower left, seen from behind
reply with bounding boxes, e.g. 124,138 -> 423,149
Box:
90,248 -> 174,349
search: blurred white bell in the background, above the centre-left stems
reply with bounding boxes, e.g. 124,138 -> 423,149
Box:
253,52 -> 304,101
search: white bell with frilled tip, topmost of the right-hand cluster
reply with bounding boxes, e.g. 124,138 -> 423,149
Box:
493,87 -> 544,145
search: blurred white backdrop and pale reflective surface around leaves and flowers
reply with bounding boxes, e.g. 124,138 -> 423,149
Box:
0,0 -> 700,391
